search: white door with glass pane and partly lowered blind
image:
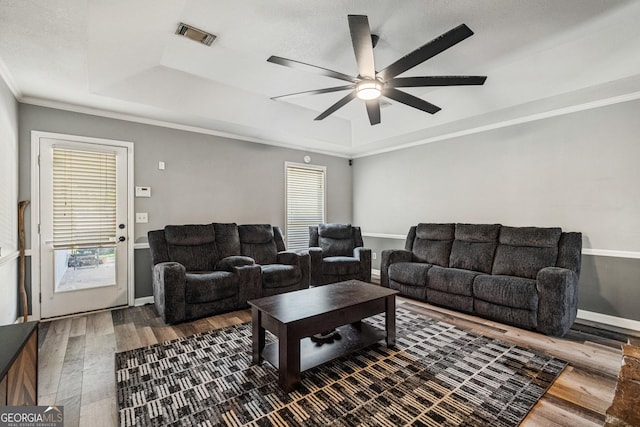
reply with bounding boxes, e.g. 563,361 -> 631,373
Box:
39,138 -> 130,318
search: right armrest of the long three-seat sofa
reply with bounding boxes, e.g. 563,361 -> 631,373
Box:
536,267 -> 578,337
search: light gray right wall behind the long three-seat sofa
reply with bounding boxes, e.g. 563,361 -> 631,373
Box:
353,101 -> 640,320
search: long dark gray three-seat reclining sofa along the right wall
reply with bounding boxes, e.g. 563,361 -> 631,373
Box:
380,224 -> 582,336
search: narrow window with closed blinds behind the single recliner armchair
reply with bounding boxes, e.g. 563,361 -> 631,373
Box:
285,162 -> 326,250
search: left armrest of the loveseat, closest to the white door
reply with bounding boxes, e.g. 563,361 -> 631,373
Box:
153,262 -> 186,324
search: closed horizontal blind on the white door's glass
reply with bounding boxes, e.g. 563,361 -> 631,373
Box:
53,148 -> 116,248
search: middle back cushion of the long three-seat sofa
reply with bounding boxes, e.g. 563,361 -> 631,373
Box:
449,224 -> 500,273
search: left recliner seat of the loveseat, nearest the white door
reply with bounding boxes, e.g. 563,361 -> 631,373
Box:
148,224 -> 261,324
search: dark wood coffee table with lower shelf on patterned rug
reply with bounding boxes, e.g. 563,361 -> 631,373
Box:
249,280 -> 398,392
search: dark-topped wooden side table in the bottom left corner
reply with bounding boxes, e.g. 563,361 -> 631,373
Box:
0,322 -> 38,406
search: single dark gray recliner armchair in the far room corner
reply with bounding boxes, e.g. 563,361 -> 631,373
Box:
309,224 -> 371,286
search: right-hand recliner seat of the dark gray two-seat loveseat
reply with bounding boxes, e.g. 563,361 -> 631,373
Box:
238,224 -> 309,296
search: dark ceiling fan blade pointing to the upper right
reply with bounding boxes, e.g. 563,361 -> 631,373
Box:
378,24 -> 473,80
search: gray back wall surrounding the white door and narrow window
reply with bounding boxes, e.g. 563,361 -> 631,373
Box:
19,104 -> 353,297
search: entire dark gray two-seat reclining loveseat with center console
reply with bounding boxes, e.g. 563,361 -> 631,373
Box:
148,223 -> 309,324
